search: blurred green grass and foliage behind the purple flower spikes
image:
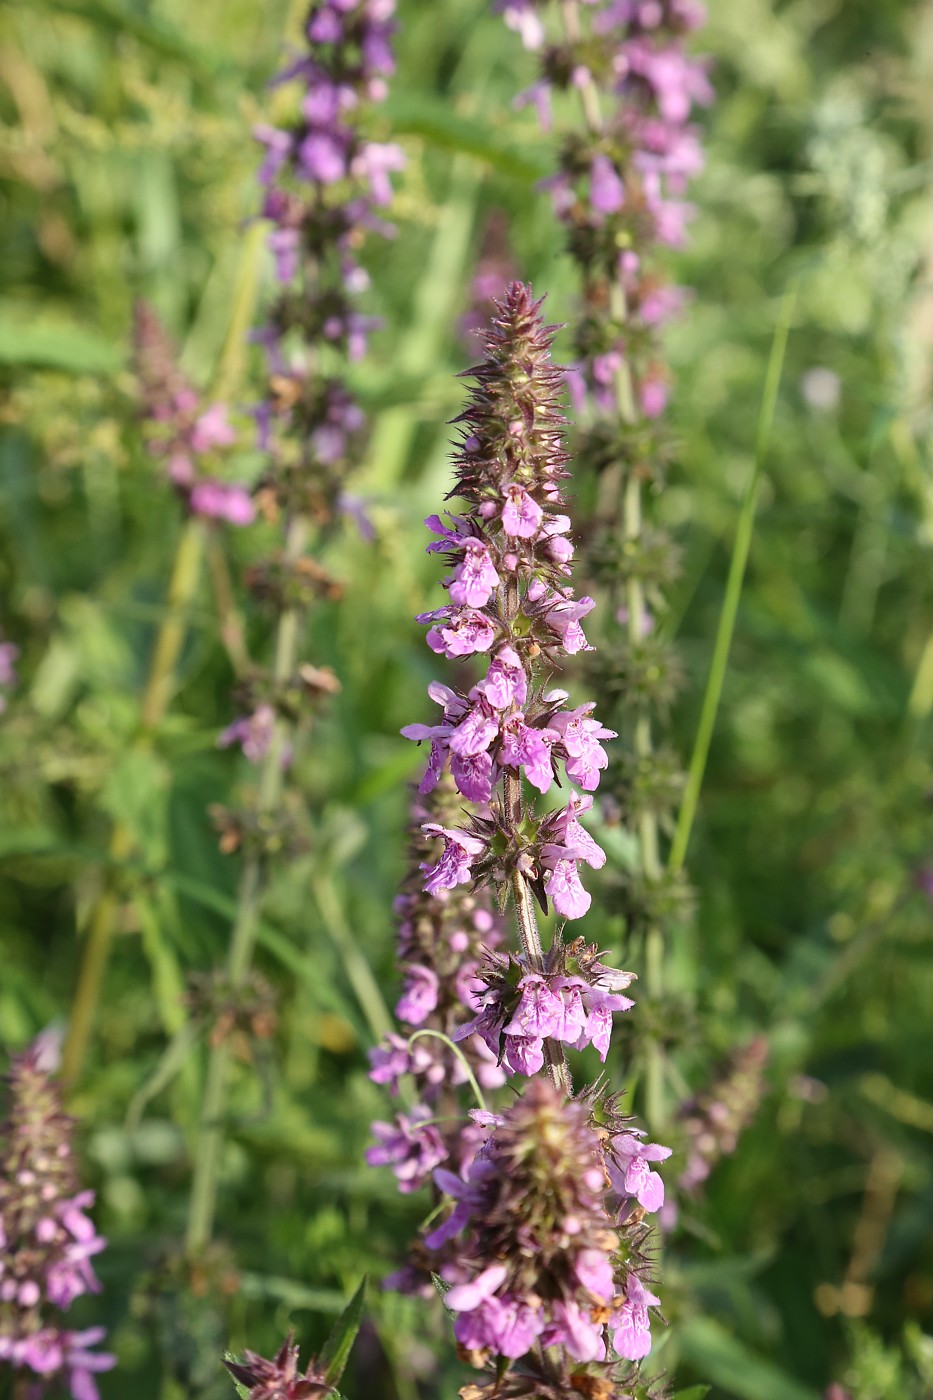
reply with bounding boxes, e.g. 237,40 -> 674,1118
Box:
0,0 -> 933,1400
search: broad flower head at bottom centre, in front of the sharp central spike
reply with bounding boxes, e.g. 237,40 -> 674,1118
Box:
426,1078 -> 668,1369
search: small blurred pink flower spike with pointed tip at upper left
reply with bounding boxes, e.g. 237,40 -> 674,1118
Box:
133,301 -> 255,525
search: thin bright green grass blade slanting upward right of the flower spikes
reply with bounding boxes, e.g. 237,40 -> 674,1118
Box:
668,280 -> 797,869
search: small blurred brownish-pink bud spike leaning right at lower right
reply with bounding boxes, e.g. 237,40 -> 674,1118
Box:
677,1036 -> 768,1193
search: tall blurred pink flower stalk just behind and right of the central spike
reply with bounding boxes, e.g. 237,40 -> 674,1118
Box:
496,0 -> 712,1126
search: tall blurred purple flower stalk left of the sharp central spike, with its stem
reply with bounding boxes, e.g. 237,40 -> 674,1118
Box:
186,0 -> 402,1254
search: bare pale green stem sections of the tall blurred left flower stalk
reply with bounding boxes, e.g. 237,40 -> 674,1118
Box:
185,515 -> 307,1256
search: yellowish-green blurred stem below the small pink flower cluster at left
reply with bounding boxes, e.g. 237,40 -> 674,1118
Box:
62,517 -> 205,1084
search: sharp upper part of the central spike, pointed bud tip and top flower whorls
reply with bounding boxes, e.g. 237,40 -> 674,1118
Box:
402,283 -> 615,918
